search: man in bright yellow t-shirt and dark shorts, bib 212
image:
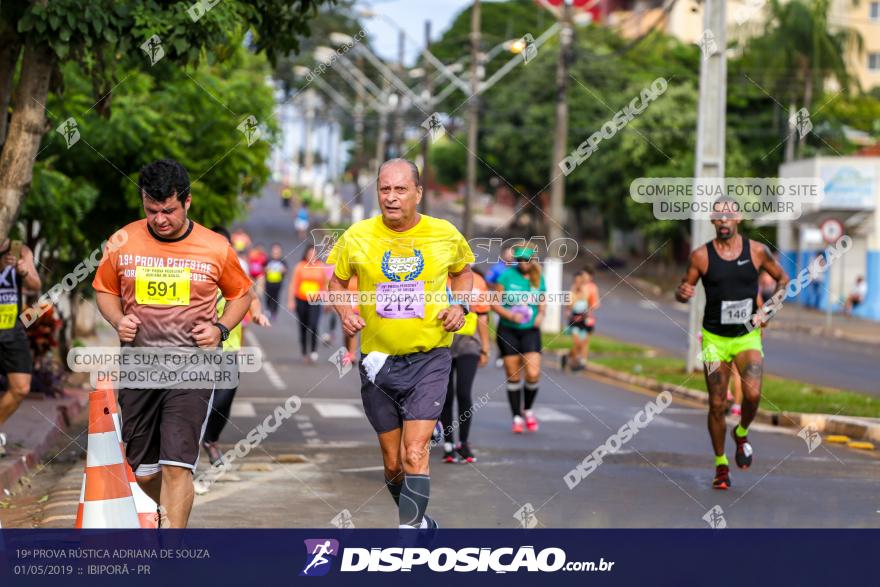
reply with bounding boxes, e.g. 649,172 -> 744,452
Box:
328,159 -> 474,528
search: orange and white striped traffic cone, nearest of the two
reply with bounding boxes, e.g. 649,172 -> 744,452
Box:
75,385 -> 140,528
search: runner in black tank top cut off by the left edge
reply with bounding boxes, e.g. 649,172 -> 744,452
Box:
0,239 -> 40,456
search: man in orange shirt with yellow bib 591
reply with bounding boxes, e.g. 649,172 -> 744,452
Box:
92,159 -> 253,528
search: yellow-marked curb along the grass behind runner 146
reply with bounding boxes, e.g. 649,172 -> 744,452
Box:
560,356 -> 880,450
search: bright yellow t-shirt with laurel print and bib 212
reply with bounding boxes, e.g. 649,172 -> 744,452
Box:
327,215 -> 474,355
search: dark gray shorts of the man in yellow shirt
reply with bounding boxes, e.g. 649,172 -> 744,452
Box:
360,347 -> 452,434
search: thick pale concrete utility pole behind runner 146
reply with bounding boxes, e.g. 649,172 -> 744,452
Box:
687,0 -> 727,373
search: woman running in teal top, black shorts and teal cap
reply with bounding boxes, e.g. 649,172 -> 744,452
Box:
492,247 -> 547,434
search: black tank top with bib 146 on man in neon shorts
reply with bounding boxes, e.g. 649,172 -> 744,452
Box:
702,237 -> 758,337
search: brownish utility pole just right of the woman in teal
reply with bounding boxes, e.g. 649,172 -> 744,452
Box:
538,0 -> 574,242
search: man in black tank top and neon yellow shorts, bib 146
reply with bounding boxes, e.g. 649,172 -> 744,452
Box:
675,198 -> 788,489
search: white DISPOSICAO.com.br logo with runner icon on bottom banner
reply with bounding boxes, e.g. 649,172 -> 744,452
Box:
300,539 -> 614,577
